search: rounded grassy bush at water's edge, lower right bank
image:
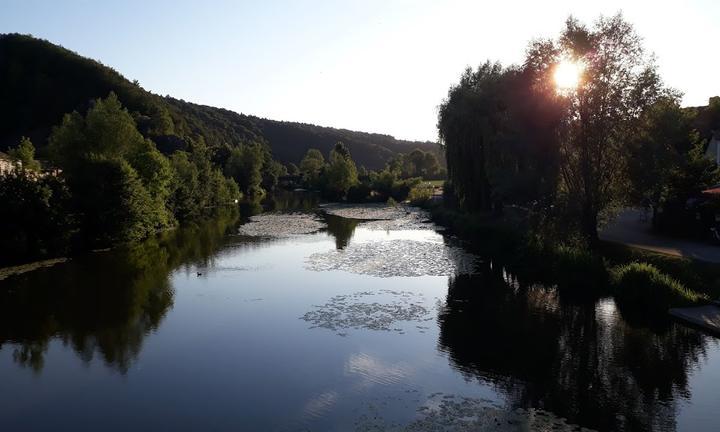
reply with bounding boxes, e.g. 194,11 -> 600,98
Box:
610,262 -> 703,308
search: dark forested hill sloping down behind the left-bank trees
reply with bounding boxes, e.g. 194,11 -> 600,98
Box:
0,34 -> 438,169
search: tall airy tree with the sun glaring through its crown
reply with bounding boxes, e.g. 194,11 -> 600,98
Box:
528,14 -> 667,244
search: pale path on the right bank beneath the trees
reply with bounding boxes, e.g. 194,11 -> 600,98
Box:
600,209 -> 720,263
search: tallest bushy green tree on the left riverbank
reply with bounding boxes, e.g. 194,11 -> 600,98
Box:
50,93 -> 174,245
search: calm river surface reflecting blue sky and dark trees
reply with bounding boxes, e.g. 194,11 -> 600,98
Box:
0,200 -> 720,431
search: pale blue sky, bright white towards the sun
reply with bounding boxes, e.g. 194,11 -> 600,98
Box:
0,0 -> 720,141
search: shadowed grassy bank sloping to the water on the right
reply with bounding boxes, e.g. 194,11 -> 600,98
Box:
425,204 -> 720,310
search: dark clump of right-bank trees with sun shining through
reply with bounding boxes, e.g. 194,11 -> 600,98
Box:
438,15 -> 720,245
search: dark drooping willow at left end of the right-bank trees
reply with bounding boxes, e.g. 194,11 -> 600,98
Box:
438,62 -> 504,210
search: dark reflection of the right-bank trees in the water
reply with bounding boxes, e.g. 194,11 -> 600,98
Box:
439,270 -> 706,431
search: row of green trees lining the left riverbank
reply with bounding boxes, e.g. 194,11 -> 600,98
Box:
0,93 -> 242,262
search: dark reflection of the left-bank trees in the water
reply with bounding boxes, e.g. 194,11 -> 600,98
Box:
0,211 -> 238,373
